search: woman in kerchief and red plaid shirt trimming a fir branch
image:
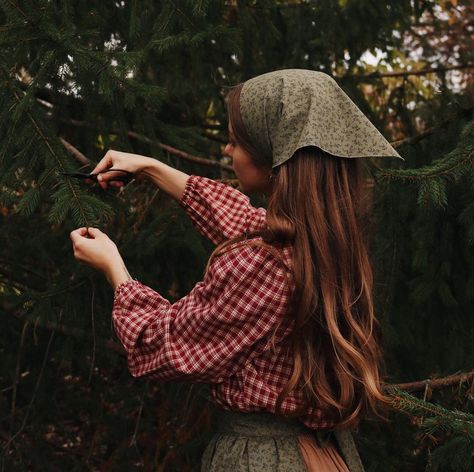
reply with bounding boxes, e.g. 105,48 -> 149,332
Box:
71,69 -> 400,472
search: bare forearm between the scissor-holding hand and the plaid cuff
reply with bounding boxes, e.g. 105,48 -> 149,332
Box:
141,157 -> 189,201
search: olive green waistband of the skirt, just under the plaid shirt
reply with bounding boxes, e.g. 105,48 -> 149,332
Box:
216,408 -> 333,447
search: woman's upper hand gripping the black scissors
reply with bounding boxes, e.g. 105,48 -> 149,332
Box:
86,149 -> 150,189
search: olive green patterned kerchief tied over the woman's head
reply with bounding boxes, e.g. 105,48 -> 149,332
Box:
240,69 -> 404,167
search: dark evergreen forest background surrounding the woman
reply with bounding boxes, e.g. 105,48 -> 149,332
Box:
0,0 -> 474,472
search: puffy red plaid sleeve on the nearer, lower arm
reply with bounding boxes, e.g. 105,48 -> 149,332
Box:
112,244 -> 290,383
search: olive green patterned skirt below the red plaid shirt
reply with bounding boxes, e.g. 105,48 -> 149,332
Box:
201,409 -> 364,472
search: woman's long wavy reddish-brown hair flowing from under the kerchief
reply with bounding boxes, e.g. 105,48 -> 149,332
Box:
208,85 -> 389,428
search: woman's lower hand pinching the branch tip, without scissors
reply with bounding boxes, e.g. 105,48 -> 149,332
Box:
70,228 -> 131,288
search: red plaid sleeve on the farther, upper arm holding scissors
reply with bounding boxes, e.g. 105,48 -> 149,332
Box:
180,175 -> 266,244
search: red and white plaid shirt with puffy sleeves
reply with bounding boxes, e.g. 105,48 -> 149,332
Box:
112,175 -> 333,428
